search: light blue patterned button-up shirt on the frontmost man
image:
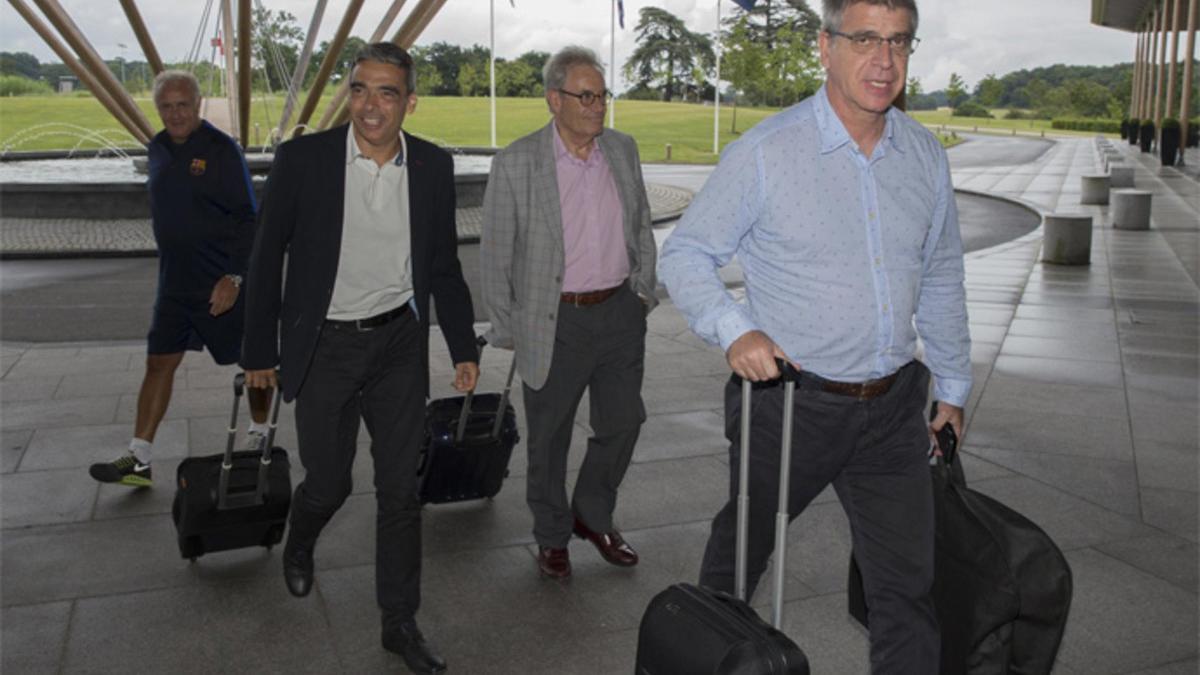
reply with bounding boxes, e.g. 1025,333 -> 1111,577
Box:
659,86 -> 971,406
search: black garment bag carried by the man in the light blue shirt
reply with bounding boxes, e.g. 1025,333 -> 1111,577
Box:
847,402 -> 1072,675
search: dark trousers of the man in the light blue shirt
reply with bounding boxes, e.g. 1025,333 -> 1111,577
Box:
700,362 -> 940,675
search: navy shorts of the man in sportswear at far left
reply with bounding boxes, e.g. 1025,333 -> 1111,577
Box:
146,293 -> 244,365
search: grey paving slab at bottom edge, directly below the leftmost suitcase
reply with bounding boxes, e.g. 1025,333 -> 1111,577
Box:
64,580 -> 341,674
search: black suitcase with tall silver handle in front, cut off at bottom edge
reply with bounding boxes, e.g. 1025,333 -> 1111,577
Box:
636,365 -> 809,675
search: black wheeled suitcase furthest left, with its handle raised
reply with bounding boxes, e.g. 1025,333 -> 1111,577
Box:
170,372 -> 292,562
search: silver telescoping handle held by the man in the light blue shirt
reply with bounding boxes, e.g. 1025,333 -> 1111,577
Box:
733,359 -> 799,629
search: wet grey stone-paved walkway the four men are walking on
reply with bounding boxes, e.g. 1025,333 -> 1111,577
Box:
0,133 -> 1200,675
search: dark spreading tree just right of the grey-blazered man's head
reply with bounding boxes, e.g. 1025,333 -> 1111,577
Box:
625,7 -> 716,101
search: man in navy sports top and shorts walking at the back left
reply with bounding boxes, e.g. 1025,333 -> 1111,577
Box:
90,71 -> 270,486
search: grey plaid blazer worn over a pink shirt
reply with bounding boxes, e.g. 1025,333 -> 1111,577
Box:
480,121 -> 658,389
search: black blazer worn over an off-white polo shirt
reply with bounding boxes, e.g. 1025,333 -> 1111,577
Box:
241,125 -> 479,401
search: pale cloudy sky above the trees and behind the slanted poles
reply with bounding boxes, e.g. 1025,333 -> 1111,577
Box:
0,0 -> 1137,91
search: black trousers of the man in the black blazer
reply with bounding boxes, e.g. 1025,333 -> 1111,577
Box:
282,311 -> 425,631
